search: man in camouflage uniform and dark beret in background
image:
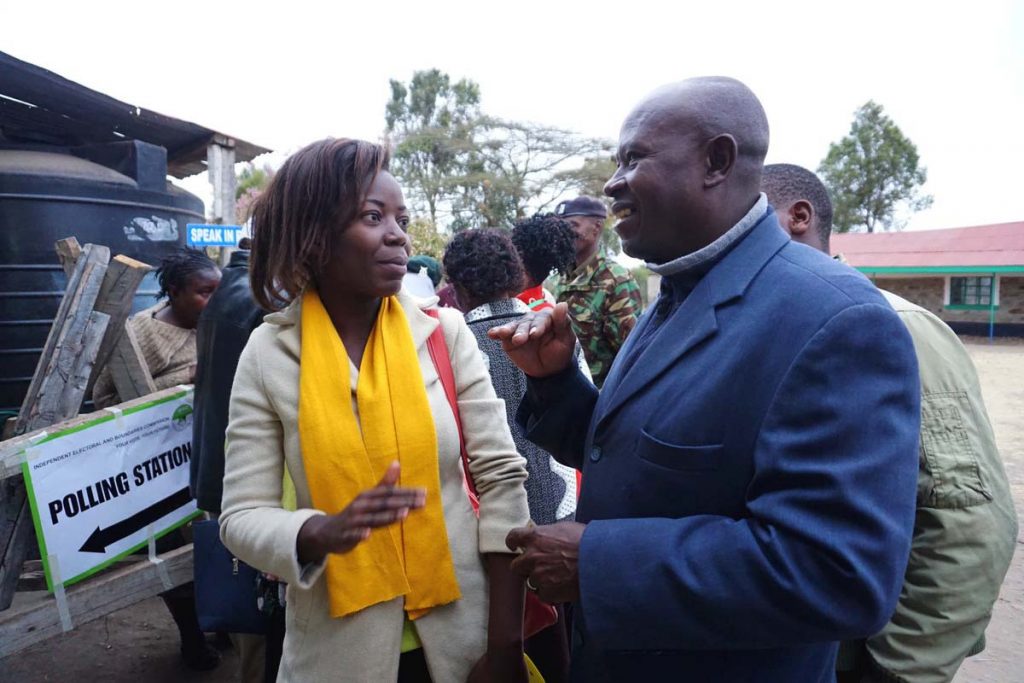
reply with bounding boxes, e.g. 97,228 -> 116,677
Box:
555,197 -> 642,387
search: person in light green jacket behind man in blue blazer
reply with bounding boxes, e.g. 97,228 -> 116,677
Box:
762,164 -> 1017,683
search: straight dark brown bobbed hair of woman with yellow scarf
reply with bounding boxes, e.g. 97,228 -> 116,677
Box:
249,137 -> 389,310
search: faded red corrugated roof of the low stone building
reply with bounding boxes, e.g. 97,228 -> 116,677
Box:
831,221 -> 1024,269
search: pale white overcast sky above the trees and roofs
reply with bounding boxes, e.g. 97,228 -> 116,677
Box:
0,0 -> 1024,229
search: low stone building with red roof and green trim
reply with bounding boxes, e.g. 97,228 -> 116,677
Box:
831,221 -> 1024,336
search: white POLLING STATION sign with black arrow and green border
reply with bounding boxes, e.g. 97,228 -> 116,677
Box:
23,390 -> 199,591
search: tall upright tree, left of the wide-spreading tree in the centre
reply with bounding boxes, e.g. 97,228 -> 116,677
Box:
384,69 -> 480,224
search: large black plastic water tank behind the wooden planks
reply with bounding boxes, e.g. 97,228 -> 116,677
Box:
0,140 -> 204,411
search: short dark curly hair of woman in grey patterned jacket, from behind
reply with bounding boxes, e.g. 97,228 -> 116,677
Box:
444,228 -> 523,302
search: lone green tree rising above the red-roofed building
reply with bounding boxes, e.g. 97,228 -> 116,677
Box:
818,100 -> 932,232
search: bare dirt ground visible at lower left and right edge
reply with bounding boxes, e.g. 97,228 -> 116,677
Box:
0,339 -> 1024,683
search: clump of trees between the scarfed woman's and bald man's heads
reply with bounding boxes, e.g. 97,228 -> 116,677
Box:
385,69 -> 611,236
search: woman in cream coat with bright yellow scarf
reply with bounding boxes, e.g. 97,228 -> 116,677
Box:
220,139 -> 528,683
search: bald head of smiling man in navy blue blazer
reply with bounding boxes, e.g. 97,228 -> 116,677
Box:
604,77 -> 768,263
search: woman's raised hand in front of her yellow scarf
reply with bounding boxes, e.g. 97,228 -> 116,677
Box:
296,461 -> 427,564
